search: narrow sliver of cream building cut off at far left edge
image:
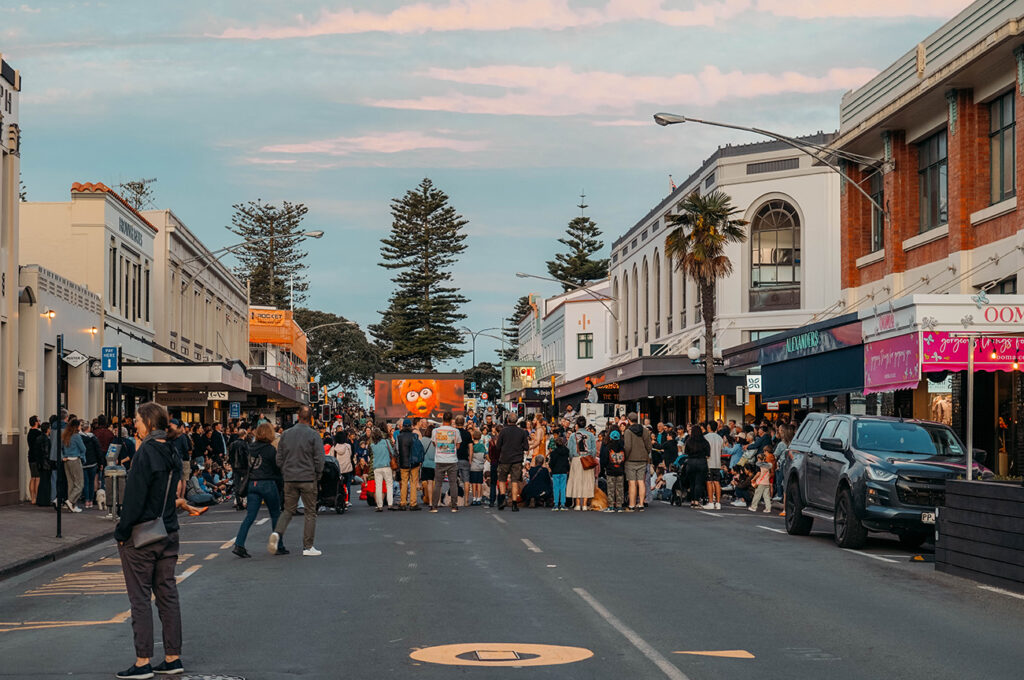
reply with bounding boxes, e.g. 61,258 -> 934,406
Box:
0,55 -> 24,505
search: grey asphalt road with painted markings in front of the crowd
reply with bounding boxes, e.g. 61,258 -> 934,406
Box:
0,503 -> 1024,680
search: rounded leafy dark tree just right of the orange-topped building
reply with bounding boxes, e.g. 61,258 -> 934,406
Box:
295,308 -> 381,393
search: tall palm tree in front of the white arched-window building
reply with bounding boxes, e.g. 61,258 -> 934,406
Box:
665,190 -> 746,420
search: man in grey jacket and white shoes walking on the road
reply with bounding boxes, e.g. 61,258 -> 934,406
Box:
266,407 -> 324,557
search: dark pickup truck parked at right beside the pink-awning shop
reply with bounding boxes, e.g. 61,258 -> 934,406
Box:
785,413 -> 991,548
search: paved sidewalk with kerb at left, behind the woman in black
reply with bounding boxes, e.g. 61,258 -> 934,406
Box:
0,503 -> 114,579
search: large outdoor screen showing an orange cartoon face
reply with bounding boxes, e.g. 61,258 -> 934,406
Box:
374,373 -> 466,420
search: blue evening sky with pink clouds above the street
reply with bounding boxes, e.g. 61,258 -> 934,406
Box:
0,0 -> 968,369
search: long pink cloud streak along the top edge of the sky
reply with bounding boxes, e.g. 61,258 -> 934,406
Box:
217,0 -> 964,40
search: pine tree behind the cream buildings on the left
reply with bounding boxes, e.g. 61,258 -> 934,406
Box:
226,200 -> 309,308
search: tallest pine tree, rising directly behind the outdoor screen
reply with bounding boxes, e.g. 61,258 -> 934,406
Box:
370,178 -> 469,371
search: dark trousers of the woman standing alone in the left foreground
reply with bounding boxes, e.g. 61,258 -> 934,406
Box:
118,532 -> 181,658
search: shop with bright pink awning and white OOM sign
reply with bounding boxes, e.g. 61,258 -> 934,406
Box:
861,295 -> 1024,475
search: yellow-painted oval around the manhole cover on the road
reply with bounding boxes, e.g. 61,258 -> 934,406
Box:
410,642 -> 594,668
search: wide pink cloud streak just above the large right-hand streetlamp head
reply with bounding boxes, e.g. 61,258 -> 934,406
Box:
364,66 -> 877,116
